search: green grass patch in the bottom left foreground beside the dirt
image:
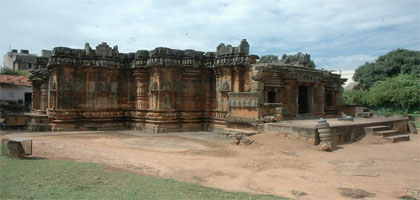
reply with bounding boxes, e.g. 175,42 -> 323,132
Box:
0,156 -> 285,199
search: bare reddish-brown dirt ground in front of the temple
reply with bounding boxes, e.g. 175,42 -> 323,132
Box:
0,131 -> 420,199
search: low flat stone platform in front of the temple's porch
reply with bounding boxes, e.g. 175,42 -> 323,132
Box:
262,116 -> 409,145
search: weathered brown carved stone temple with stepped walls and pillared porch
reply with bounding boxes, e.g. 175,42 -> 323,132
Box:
30,40 -> 345,133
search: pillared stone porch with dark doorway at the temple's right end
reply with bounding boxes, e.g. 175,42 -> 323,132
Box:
252,63 -> 344,118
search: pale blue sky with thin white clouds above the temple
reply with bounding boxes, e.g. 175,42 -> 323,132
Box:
0,0 -> 420,71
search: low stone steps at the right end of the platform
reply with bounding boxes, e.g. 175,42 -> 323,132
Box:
364,126 -> 410,143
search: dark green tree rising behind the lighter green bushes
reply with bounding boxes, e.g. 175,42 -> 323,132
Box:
353,49 -> 420,90
